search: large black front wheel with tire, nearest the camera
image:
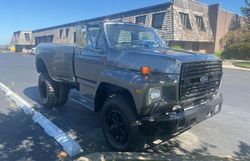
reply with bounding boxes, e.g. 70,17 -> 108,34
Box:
102,95 -> 145,151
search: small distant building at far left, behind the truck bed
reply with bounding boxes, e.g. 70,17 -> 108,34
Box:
10,31 -> 34,52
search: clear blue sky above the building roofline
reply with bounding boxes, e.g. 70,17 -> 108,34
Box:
0,0 -> 245,45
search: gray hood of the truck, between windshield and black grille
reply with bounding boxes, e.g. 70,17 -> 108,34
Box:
108,49 -> 220,74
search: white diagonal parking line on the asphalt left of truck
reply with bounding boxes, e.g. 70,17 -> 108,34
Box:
0,82 -> 83,156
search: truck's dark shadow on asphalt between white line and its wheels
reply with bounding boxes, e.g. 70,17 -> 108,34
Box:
23,86 -> 110,154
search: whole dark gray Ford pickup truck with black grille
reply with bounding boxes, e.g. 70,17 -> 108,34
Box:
36,22 -> 222,151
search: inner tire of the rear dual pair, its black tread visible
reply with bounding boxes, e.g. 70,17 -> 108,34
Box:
56,83 -> 69,106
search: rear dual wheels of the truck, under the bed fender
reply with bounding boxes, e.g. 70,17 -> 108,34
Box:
38,73 -> 69,107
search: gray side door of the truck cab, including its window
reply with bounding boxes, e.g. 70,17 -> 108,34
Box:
74,24 -> 107,99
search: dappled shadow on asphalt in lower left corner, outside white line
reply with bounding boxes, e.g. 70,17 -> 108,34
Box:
0,96 -> 60,160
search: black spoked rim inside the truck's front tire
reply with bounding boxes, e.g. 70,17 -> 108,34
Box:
105,110 -> 129,146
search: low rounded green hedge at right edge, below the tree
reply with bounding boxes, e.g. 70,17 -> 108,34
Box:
222,42 -> 250,60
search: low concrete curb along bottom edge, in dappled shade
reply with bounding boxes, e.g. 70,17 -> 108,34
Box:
75,152 -> 236,161
